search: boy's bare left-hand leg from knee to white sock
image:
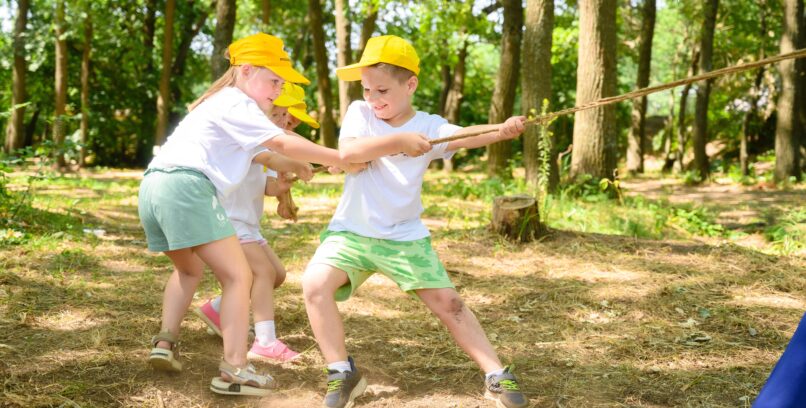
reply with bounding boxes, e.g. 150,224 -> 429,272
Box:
302,264 -> 348,363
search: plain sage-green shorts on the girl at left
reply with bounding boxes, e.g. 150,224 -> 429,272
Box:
137,167 -> 235,252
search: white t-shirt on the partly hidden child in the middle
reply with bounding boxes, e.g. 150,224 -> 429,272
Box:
218,147 -> 277,241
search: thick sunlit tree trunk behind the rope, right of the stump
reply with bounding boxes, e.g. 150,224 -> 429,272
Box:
571,0 -> 617,179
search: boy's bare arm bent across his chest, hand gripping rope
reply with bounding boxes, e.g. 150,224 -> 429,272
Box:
339,132 -> 431,163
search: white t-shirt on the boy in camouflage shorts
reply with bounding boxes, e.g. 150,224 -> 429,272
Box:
328,101 -> 461,241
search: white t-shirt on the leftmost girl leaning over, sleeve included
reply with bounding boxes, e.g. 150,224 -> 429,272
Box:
148,87 -> 285,195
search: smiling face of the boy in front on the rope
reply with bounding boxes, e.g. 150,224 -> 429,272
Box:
361,67 -> 417,121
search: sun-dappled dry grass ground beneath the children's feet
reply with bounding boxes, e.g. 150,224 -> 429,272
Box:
0,171 -> 806,407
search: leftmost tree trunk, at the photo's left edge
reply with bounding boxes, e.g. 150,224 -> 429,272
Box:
5,0 -> 31,153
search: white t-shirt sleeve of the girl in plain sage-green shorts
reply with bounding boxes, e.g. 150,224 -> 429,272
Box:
217,101 -> 285,150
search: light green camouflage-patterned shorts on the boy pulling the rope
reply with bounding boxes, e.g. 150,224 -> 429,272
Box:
310,231 -> 455,302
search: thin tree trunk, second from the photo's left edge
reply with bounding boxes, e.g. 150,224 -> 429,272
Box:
53,0 -> 67,169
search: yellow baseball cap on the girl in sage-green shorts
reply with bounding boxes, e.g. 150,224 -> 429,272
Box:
229,33 -> 311,85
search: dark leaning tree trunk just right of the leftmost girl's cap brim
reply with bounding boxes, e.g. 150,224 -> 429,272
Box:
308,0 -> 338,148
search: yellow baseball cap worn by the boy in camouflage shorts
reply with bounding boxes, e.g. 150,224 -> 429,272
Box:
336,35 -> 420,81
